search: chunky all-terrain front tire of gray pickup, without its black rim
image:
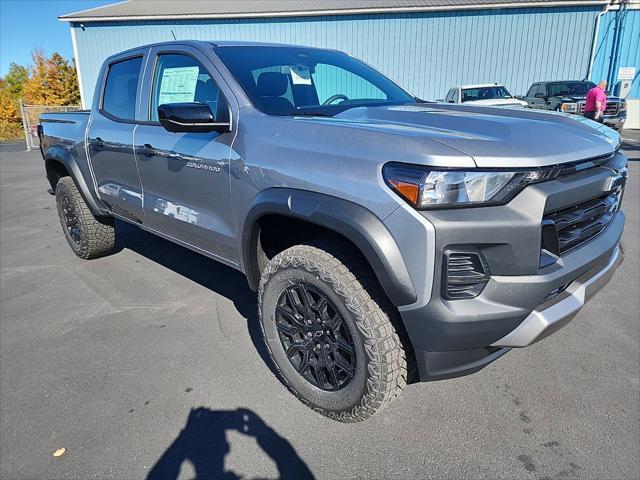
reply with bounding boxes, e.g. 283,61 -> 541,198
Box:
258,240 -> 407,423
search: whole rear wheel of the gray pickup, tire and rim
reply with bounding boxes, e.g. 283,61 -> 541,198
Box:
56,177 -> 116,260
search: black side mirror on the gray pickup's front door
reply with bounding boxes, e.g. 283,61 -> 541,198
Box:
158,102 -> 231,133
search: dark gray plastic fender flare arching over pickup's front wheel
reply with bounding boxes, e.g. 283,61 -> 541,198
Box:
242,188 -> 417,306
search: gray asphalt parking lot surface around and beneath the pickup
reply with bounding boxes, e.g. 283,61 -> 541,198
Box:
0,131 -> 640,479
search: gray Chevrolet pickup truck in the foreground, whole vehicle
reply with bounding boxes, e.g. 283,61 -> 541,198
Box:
39,41 -> 627,422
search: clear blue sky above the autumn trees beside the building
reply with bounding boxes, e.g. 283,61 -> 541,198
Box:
0,0 -> 117,76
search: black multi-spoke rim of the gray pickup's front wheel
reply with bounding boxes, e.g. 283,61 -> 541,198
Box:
275,283 -> 356,392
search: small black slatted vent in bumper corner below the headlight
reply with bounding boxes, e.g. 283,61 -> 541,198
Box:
443,251 -> 489,300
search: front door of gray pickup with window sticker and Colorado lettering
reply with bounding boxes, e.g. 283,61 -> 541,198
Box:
134,46 -> 238,263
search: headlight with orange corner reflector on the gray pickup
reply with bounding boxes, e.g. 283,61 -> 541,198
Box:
382,163 -> 558,209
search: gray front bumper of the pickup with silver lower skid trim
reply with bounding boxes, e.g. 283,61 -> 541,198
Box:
391,154 -> 626,380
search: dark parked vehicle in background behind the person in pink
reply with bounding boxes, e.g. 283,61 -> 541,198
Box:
523,80 -> 627,130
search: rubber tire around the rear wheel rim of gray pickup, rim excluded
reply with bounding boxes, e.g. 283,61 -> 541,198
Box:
56,177 -> 116,260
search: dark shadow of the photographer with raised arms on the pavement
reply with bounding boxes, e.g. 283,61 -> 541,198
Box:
147,407 -> 314,480
